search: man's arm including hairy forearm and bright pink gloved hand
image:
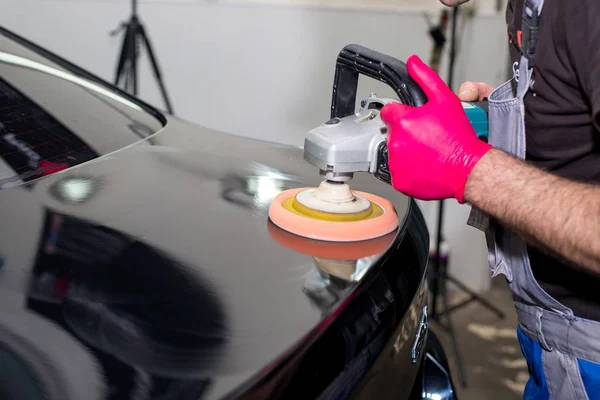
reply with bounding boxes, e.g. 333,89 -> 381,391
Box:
381,56 -> 600,274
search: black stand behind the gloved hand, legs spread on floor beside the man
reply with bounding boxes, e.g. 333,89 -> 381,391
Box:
430,7 -> 505,387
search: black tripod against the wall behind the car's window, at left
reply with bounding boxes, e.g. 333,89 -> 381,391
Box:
111,0 -> 173,114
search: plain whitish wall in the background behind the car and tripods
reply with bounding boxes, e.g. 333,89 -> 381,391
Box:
0,0 -> 507,290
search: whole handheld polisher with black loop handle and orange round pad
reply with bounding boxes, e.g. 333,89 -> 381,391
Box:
269,44 -> 488,241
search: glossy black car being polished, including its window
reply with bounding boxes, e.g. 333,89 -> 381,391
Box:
0,25 -> 455,400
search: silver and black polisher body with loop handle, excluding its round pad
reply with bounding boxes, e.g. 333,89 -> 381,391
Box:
304,44 -> 488,183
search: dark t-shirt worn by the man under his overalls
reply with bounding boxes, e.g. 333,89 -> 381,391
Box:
506,0 -> 600,320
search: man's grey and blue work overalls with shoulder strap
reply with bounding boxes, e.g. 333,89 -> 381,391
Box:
468,0 -> 600,400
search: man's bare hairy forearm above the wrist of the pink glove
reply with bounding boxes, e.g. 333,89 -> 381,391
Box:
464,149 -> 600,274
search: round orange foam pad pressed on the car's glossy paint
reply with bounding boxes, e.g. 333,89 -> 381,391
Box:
269,188 -> 398,242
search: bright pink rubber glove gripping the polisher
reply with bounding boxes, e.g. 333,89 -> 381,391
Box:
381,55 -> 491,203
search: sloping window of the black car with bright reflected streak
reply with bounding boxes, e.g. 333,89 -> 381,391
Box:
0,30 -> 165,189
